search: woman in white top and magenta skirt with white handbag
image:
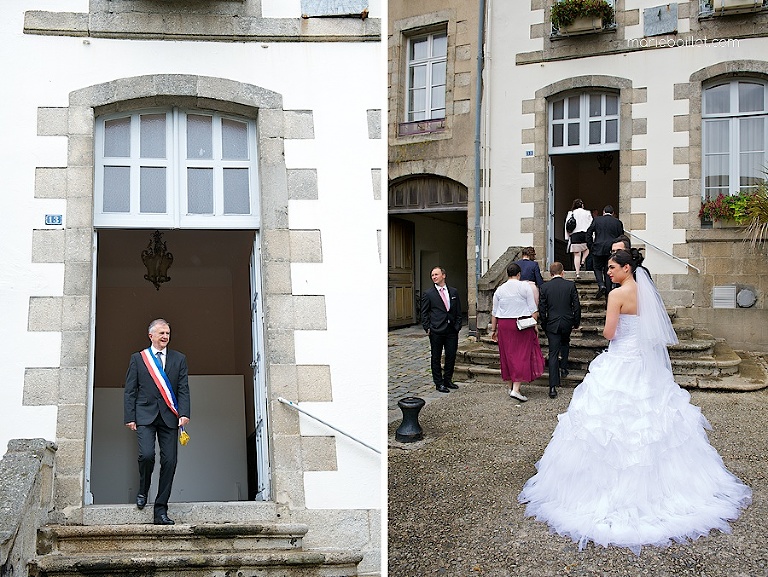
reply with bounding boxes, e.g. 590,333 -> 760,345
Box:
491,262 -> 544,402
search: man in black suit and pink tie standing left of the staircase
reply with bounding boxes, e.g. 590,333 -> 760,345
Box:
421,266 -> 461,393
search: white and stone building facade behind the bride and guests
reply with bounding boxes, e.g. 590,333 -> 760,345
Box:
482,0 -> 768,351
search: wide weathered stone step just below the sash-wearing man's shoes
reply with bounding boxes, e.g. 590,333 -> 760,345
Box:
37,523 -> 307,555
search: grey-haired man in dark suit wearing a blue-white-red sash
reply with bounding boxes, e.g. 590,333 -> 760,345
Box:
124,319 -> 189,525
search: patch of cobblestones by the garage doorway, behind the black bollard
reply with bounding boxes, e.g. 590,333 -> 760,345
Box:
387,325 -> 468,423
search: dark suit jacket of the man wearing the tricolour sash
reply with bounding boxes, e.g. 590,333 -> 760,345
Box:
124,348 -> 189,429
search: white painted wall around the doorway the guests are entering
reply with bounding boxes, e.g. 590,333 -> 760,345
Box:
485,0 -> 768,273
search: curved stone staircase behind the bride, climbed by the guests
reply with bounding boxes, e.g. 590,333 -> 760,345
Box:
455,271 -> 768,390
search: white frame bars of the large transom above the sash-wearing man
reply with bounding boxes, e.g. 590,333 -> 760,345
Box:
93,108 -> 261,229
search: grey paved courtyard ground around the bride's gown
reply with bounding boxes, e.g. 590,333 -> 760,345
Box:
388,327 -> 768,577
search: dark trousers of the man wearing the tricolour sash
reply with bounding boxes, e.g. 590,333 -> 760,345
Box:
136,415 -> 179,517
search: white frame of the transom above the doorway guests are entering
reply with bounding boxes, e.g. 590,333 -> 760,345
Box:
548,90 -> 621,154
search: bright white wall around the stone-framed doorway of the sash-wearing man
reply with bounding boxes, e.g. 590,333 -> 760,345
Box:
0,0 -> 386,508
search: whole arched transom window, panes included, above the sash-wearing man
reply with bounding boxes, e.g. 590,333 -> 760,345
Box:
94,108 -> 259,228
